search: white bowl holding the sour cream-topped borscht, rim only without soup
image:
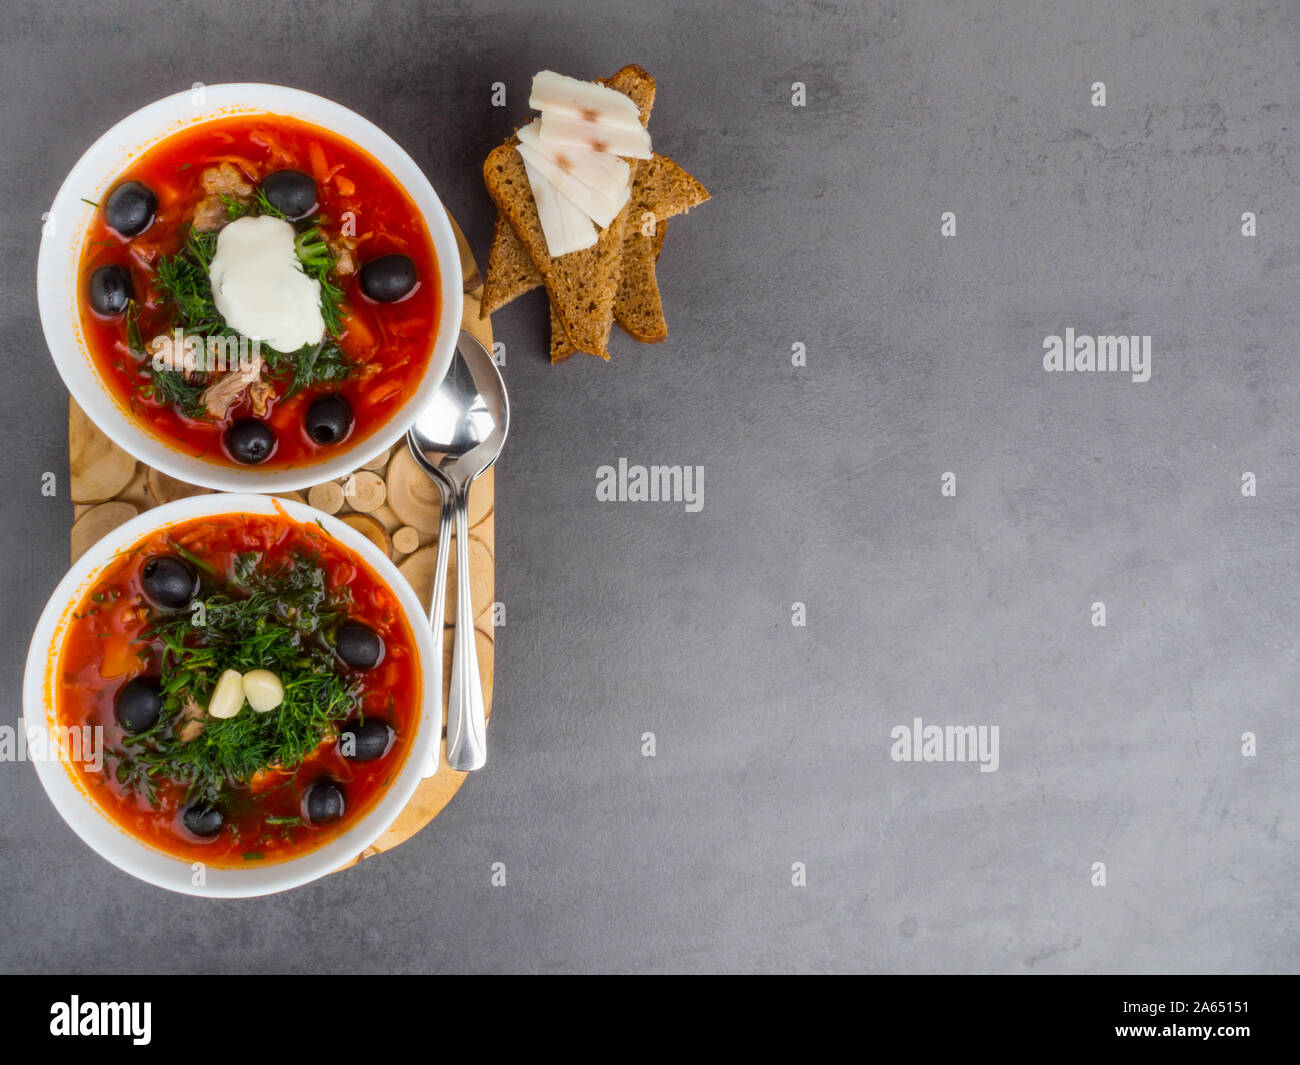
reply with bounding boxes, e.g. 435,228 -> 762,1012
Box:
36,83 -> 462,492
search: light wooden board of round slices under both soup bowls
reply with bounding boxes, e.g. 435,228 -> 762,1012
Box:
68,215 -> 495,869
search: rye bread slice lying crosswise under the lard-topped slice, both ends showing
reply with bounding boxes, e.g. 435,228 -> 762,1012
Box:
480,155 -> 709,321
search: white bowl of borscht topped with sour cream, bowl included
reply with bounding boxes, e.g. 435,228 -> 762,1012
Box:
36,85 -> 463,492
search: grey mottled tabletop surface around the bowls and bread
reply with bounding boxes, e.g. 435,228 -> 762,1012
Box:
0,0 -> 1300,973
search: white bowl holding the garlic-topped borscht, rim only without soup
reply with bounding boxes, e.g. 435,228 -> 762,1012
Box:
22,494 -> 442,899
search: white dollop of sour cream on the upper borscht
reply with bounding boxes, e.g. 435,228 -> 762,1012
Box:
208,215 -> 325,351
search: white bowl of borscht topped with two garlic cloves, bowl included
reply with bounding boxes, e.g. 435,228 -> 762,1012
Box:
23,493 -> 442,897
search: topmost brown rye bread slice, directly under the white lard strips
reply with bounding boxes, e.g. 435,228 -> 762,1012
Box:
484,66 -> 655,359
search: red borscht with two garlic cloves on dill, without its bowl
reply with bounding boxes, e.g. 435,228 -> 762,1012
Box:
53,511 -> 421,867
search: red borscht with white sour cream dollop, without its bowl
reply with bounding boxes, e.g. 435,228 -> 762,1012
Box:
78,114 -> 441,469
